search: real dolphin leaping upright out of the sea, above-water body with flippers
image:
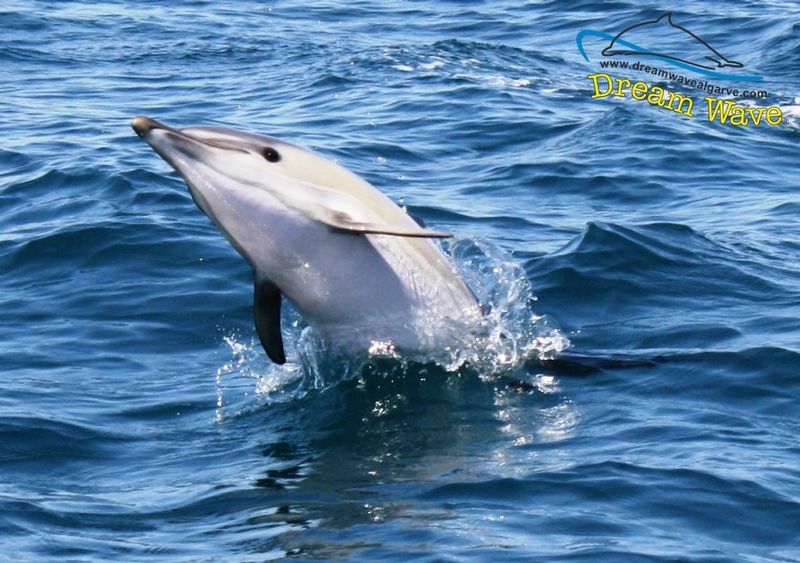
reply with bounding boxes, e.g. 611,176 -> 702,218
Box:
131,117 -> 480,363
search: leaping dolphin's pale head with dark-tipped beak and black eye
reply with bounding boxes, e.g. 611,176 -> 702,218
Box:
131,117 -> 384,263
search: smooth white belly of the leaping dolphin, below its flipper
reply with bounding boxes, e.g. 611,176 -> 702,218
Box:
214,187 -> 477,348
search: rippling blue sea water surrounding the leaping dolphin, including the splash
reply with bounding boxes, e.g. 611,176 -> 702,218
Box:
0,0 -> 800,562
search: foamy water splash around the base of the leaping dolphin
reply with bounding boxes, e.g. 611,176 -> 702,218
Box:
216,239 -> 570,417
